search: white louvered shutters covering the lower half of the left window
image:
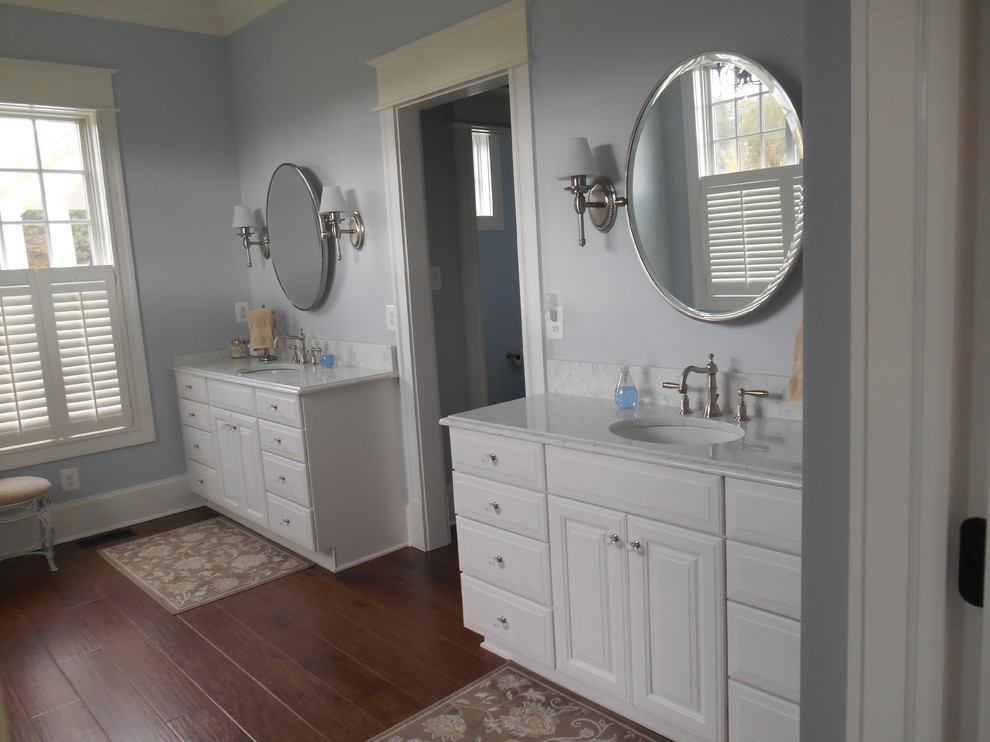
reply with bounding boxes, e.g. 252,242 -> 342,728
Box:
0,266 -> 132,454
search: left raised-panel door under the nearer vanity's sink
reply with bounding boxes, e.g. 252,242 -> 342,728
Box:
549,497 -> 628,698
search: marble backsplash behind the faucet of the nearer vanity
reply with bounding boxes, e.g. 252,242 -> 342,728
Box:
547,360 -> 803,421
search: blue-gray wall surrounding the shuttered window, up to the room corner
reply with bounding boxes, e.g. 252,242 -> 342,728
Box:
0,4 -> 248,501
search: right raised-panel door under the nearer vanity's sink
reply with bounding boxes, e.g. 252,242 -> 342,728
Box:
627,516 -> 726,740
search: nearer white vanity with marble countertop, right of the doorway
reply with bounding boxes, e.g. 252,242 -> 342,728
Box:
442,394 -> 801,742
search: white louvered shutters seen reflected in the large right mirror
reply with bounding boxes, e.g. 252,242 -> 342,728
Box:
702,166 -> 801,298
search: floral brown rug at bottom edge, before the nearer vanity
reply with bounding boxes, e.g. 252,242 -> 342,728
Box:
368,664 -> 670,742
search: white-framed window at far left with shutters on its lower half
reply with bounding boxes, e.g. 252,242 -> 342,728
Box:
0,59 -> 154,469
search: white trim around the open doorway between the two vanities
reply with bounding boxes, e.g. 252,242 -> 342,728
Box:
369,0 -> 546,549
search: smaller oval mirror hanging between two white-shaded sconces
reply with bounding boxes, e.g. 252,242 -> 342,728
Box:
265,163 -> 334,310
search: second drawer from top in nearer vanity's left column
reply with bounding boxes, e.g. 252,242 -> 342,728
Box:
454,472 -> 547,541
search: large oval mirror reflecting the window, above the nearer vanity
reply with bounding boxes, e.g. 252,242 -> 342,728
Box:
626,52 -> 804,322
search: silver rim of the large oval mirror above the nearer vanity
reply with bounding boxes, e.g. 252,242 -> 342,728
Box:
626,52 -> 804,322
